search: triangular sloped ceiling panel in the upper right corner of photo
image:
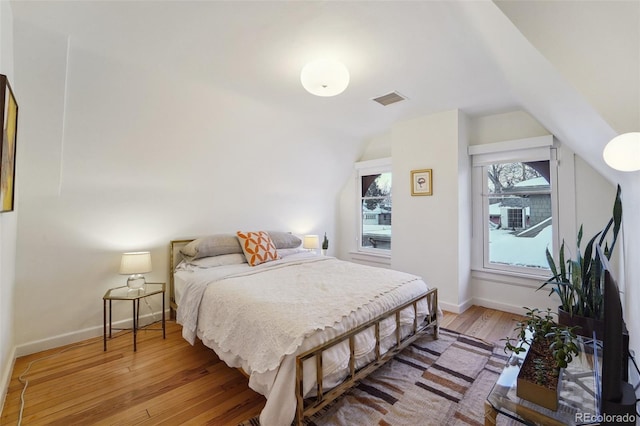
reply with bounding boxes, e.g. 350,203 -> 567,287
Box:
496,0 -> 640,136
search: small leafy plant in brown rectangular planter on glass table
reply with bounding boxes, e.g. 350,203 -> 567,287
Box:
503,308 -> 578,411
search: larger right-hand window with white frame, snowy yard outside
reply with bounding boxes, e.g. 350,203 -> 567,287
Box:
469,137 -> 557,276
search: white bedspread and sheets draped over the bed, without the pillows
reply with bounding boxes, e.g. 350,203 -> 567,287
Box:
175,253 -> 436,426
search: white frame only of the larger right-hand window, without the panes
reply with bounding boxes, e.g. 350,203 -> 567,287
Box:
469,135 -> 560,279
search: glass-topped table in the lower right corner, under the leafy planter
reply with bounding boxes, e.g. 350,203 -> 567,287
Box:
484,338 -> 602,426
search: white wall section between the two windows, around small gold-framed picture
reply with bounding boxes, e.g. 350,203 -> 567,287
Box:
391,110 -> 470,312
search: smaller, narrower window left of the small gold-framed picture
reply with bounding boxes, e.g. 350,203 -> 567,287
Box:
356,159 -> 392,254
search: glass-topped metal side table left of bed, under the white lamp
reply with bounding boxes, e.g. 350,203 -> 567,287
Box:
102,283 -> 167,352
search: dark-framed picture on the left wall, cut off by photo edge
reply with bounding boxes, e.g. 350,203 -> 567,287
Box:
0,74 -> 18,213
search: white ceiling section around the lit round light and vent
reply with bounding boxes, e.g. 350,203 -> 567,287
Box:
13,1 -> 515,134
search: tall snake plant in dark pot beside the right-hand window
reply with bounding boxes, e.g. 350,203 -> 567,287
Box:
538,185 -> 622,340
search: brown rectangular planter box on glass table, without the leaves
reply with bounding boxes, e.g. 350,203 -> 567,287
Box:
516,340 -> 562,411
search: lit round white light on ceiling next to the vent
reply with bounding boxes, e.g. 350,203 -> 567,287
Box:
300,59 -> 349,96
